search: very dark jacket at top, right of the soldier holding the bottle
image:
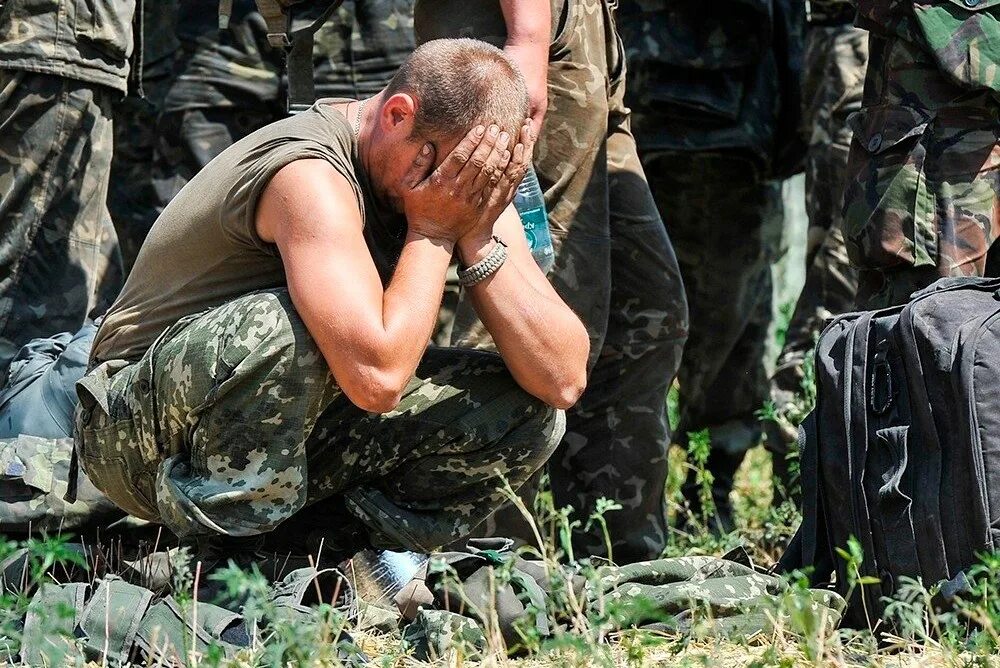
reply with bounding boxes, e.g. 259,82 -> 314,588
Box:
618,0 -> 805,175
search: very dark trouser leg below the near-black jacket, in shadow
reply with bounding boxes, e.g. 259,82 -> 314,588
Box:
646,152 -> 781,528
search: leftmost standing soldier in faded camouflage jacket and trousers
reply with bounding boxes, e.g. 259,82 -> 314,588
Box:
0,0 -> 135,378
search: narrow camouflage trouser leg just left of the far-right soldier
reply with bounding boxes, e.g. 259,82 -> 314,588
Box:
765,25 -> 868,465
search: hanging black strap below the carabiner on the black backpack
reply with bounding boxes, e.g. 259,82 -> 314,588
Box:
875,427 -> 920,576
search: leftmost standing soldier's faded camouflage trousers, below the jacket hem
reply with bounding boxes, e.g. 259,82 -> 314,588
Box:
0,70 -> 122,379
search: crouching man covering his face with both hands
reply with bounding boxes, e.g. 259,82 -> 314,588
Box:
77,40 -> 588,551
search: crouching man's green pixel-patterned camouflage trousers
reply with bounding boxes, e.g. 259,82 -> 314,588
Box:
77,290 -> 564,552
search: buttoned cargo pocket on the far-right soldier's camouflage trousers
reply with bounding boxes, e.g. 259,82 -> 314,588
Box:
844,106 -> 937,269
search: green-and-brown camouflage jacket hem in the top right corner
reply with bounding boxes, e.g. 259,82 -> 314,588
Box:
856,0 -> 1000,98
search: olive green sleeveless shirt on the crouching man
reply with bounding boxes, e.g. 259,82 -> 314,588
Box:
91,100 -> 405,365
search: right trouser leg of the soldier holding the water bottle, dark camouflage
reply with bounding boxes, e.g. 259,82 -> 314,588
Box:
549,77 -> 687,563
